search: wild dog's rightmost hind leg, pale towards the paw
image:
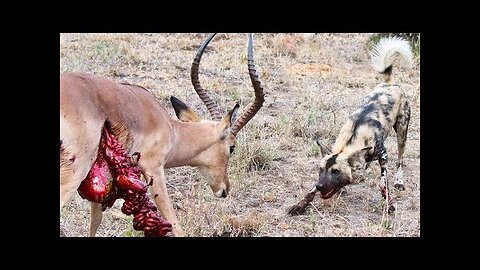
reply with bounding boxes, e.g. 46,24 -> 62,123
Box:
393,98 -> 410,190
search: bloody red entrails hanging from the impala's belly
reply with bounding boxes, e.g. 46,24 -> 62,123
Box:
78,122 -> 172,236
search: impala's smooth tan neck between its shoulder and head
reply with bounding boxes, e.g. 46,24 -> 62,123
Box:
165,121 -> 219,168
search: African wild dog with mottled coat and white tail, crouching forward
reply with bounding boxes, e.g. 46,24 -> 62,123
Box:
288,38 -> 412,215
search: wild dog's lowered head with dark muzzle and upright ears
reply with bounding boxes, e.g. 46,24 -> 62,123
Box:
315,140 -> 372,199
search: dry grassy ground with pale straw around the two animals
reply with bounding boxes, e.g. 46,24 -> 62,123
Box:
60,34 -> 420,237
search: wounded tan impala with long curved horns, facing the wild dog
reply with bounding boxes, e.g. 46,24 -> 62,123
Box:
60,34 -> 264,236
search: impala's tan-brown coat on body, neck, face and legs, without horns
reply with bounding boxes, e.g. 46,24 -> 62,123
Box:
60,73 -> 235,235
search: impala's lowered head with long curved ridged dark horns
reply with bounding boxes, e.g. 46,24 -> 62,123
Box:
171,34 -> 264,198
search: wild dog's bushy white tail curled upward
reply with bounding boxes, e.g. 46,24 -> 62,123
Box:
371,37 -> 413,83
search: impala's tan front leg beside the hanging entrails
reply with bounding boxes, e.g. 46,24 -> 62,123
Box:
144,166 -> 185,236
